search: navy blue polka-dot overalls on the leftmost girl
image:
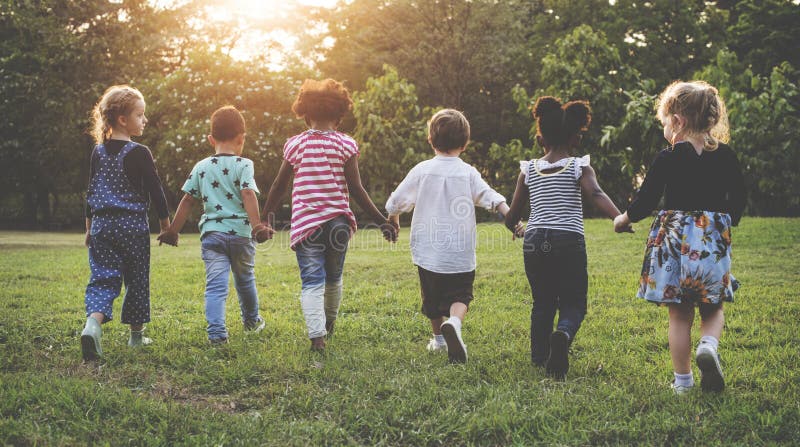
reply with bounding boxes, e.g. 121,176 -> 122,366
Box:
85,142 -> 150,324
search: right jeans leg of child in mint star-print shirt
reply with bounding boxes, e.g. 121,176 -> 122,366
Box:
229,236 -> 259,327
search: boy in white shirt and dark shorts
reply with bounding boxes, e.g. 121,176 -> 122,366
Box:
386,109 -> 508,363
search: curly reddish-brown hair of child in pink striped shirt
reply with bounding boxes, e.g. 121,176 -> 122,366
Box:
292,79 -> 353,122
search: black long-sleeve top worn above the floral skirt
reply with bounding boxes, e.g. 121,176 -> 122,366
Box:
628,142 -> 746,225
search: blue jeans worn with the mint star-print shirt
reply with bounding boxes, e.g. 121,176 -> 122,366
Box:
200,231 -> 259,340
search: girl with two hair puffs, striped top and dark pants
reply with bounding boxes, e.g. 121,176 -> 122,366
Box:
506,96 -> 632,379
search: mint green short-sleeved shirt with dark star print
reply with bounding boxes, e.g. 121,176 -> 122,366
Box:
181,154 -> 259,238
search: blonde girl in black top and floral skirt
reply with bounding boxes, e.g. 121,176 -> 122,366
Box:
614,81 -> 745,394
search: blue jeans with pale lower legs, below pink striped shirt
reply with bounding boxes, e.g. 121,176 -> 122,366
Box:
295,216 -> 351,338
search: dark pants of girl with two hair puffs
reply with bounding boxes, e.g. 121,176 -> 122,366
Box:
523,228 -> 588,364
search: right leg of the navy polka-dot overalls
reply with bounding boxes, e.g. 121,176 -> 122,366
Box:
118,233 -> 150,331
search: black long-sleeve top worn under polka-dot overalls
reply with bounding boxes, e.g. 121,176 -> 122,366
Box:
86,140 -> 169,219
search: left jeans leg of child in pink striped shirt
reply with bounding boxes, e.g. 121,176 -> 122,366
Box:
295,236 -> 326,340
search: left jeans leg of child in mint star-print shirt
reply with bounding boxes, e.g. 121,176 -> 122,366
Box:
200,232 -> 231,342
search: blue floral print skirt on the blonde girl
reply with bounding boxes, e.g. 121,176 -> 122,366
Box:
637,210 -> 738,306
